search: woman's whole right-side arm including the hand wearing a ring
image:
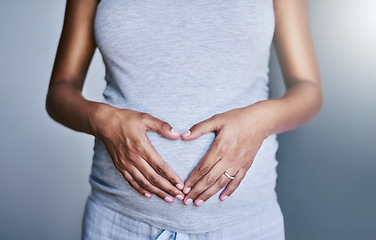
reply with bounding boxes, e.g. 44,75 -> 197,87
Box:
182,0 -> 322,206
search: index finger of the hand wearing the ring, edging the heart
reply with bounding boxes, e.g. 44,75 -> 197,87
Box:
183,138 -> 222,194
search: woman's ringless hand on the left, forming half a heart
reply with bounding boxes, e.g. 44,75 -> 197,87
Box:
90,104 -> 184,203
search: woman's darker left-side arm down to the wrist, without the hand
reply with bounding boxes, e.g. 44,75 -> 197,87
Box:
46,0 -> 100,134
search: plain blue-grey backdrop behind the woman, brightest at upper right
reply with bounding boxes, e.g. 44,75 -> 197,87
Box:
0,0 -> 376,240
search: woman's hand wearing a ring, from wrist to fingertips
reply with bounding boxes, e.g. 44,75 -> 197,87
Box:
182,103 -> 270,206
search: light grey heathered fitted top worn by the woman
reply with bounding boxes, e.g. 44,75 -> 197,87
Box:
90,0 -> 278,233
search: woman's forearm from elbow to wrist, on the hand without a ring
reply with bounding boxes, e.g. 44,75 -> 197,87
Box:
46,81 -> 110,136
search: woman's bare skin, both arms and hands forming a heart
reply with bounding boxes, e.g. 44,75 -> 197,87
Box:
46,0 -> 322,206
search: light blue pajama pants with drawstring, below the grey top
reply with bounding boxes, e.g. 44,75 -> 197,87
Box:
82,197 -> 285,240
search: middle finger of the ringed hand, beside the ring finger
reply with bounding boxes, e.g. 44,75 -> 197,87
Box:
184,159 -> 232,205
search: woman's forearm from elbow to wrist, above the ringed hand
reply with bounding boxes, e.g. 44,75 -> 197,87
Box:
254,81 -> 322,136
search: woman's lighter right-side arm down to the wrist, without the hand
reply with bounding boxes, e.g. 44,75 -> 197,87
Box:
265,0 -> 322,134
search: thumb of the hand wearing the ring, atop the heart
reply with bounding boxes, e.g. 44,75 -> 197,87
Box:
181,114 -> 222,140
